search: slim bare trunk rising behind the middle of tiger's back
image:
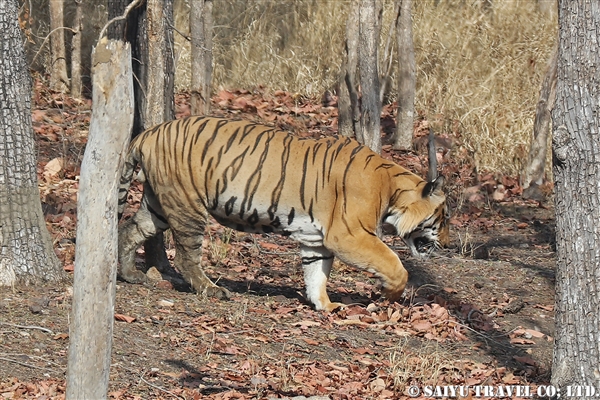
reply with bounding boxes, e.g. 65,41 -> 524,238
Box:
190,0 -> 213,115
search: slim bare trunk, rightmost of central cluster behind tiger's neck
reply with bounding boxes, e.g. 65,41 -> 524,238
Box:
393,0 -> 417,150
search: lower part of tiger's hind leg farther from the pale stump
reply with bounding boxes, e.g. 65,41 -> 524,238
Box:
170,216 -> 231,299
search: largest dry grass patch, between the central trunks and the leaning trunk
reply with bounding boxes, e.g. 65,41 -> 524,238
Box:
414,1 -> 556,175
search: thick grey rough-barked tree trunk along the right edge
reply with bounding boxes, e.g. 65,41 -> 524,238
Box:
551,0 -> 600,390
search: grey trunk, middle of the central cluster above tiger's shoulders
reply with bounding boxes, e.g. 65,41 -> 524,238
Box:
357,0 -> 381,153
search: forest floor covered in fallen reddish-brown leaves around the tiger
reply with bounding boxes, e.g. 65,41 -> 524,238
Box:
0,82 -> 555,399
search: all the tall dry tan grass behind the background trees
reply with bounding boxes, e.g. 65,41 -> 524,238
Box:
176,0 -> 557,175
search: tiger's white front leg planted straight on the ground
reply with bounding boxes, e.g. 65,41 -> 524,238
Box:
300,245 -> 344,312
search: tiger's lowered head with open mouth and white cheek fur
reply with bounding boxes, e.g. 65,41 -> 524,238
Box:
386,176 -> 450,257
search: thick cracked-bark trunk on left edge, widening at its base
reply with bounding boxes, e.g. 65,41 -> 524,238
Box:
0,1 -> 64,286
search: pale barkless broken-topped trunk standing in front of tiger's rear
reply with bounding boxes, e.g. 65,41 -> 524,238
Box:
66,39 -> 133,399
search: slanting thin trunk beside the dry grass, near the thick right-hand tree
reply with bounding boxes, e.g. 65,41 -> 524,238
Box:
523,43 -> 558,189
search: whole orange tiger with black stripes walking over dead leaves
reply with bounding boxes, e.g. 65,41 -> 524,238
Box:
118,116 -> 449,312
